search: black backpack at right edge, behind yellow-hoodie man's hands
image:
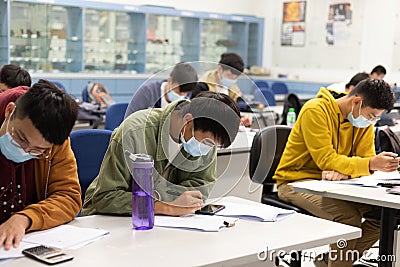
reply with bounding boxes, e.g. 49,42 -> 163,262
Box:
375,126 -> 400,155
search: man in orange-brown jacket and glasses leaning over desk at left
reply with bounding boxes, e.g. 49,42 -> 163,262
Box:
0,80 -> 82,250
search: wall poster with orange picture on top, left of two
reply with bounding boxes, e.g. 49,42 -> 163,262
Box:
281,1 -> 306,46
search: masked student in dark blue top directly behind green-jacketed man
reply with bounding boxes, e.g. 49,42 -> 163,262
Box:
125,62 -> 198,118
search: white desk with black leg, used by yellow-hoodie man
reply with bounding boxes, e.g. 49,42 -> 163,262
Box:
292,180 -> 400,267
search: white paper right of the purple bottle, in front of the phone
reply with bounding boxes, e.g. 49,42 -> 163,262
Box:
154,215 -> 237,232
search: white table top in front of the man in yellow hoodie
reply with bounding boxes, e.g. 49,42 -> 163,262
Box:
291,180 -> 400,209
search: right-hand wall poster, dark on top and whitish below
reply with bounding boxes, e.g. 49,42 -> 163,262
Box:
325,2 -> 353,46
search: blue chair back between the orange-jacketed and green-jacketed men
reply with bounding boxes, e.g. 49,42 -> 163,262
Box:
70,129 -> 112,201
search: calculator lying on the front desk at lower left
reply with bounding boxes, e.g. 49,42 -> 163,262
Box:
22,245 -> 74,265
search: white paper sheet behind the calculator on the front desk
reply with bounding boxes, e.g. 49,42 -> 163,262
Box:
23,225 -> 109,249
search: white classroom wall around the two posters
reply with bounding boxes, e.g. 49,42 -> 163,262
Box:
83,0 -> 400,84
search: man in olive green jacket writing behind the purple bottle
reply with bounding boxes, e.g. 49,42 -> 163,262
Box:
82,92 -> 240,216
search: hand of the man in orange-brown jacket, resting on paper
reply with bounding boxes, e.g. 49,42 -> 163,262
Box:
0,214 -> 31,250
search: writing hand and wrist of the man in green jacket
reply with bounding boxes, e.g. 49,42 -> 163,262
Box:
154,191 -> 203,216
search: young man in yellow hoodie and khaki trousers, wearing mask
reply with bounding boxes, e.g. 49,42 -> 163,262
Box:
274,79 -> 399,267
